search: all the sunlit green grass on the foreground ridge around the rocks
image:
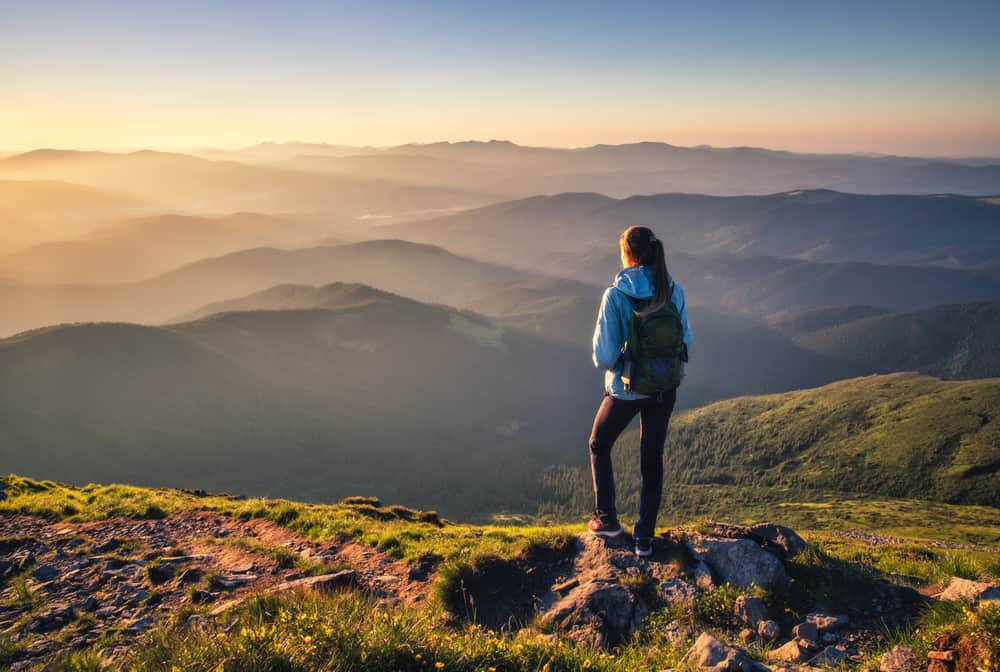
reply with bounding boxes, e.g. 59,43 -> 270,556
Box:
0,477 -> 1000,672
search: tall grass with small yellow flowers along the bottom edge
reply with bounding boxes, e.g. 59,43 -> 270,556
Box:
99,593 -> 696,672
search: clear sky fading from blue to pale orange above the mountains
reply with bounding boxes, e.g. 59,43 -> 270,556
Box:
0,0 -> 1000,156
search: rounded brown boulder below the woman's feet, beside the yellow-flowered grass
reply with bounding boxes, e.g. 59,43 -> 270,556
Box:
544,579 -> 646,645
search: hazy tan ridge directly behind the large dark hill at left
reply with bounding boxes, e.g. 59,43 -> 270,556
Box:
0,240 -> 531,335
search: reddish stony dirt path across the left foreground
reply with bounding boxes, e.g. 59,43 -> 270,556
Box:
0,511 -> 430,660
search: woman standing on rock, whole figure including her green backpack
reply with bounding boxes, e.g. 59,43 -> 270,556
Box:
588,226 -> 691,557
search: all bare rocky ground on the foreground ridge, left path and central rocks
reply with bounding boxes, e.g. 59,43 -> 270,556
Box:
0,511 -> 1000,672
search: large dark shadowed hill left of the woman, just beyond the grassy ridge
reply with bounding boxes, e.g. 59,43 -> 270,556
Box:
0,288 -> 601,515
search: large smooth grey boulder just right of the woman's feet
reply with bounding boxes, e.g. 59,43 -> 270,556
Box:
685,536 -> 788,588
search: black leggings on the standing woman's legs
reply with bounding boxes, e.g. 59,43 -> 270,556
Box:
590,390 -> 677,537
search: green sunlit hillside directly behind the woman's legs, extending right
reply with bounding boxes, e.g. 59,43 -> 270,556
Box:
543,373 -> 1000,513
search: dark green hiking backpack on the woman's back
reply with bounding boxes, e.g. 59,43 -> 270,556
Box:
622,292 -> 687,394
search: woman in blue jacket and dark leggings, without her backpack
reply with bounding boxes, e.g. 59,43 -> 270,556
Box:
588,226 -> 691,557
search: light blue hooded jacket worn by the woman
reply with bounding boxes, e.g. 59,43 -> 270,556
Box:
594,266 -> 691,399
